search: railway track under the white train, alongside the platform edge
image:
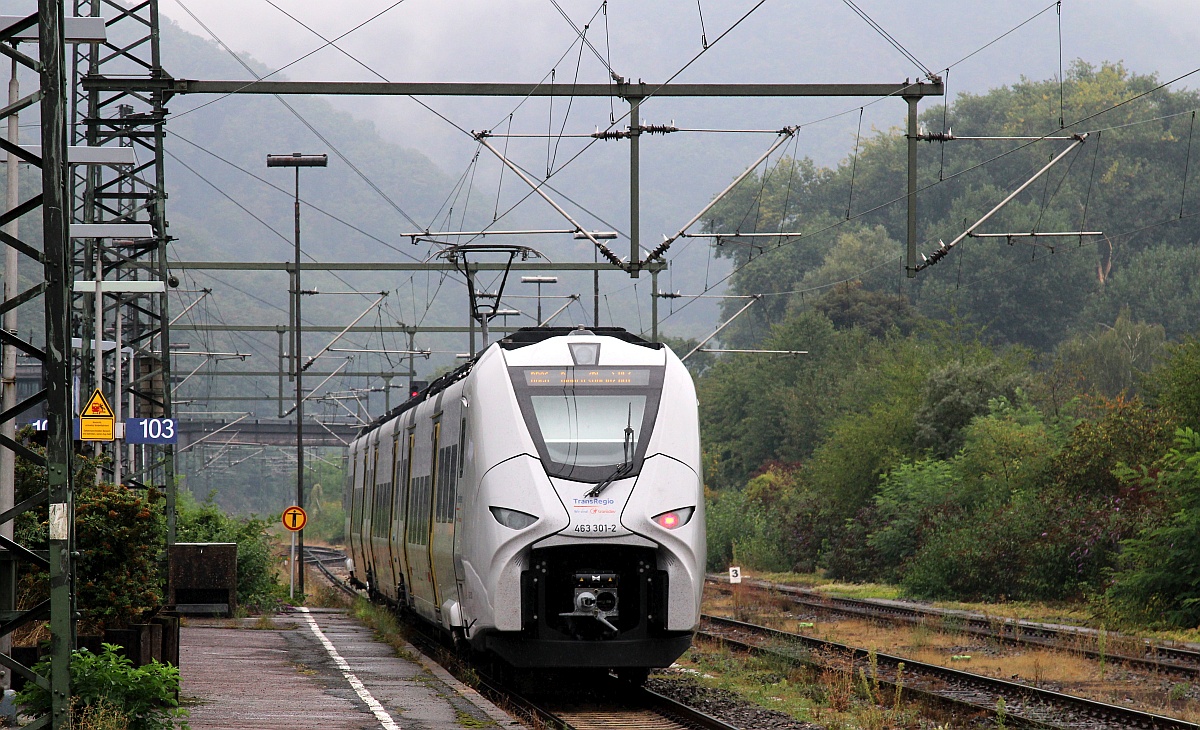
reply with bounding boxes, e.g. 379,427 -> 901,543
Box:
305,546 -> 740,730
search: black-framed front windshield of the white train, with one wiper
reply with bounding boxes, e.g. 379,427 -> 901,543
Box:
511,367 -> 662,481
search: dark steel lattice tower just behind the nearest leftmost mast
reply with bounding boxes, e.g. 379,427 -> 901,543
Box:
71,0 -> 175,535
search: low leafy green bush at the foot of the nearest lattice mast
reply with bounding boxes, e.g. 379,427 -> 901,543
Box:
17,644 -> 187,730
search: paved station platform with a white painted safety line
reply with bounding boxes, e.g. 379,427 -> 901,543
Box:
179,609 -> 522,730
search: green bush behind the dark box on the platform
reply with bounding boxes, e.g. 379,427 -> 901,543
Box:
175,491 -> 284,609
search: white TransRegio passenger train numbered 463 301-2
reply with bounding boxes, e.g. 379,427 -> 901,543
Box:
346,328 -> 704,677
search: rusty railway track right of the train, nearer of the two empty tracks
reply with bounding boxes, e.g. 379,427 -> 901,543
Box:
698,615 -> 1200,730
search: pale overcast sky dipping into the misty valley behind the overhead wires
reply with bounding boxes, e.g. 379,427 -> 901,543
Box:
145,0 -> 1200,340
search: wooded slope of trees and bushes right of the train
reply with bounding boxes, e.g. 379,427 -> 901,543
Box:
700,62 -> 1200,626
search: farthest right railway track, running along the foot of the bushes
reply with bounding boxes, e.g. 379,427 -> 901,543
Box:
708,576 -> 1200,680
